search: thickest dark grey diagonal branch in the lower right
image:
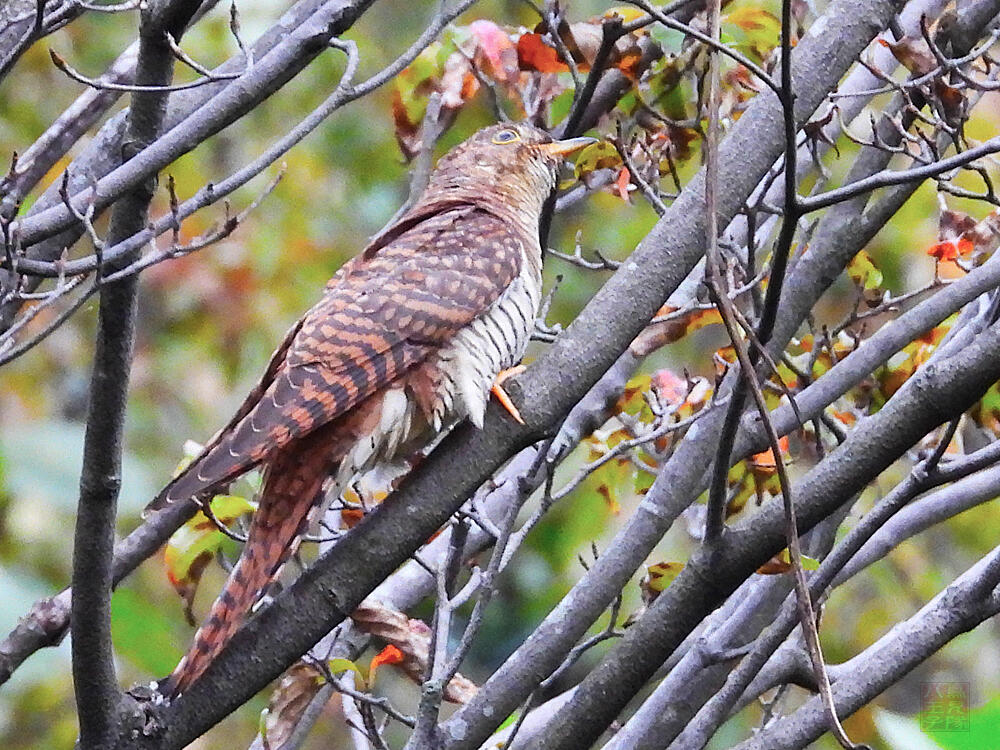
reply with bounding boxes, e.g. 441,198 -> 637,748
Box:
516,318 -> 1000,750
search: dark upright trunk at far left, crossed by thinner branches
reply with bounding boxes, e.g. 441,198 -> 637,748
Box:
71,0 -> 201,749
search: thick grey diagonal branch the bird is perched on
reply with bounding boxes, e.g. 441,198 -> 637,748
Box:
95,0 -> 908,747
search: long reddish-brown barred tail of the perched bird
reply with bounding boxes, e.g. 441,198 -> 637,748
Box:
160,429 -> 339,697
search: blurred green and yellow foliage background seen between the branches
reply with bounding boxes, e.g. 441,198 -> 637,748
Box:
0,0 -> 1000,750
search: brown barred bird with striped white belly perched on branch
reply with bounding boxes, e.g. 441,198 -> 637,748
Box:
148,123 -> 596,699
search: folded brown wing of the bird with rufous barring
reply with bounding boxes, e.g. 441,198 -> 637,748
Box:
150,206 -> 523,509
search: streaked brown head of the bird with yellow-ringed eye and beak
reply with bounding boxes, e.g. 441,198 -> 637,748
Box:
426,123 -> 597,226
